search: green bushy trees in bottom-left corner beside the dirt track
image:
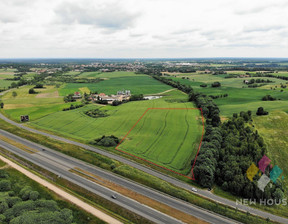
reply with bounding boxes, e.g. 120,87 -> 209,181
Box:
0,170 -> 74,224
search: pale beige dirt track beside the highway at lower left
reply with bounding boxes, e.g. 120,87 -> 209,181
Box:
0,155 -> 122,224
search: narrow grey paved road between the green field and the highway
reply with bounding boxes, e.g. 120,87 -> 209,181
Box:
0,113 -> 288,224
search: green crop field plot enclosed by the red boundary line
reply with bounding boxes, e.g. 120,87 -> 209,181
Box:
118,108 -> 201,173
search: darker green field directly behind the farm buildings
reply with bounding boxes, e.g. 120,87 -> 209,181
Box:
59,72 -> 171,96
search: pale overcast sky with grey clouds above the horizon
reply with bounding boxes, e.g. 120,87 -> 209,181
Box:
0,0 -> 288,58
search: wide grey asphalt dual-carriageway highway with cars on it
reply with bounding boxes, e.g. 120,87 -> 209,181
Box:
0,129 -> 235,224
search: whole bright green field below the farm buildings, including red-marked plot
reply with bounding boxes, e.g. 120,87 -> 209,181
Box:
30,90 -> 202,174
